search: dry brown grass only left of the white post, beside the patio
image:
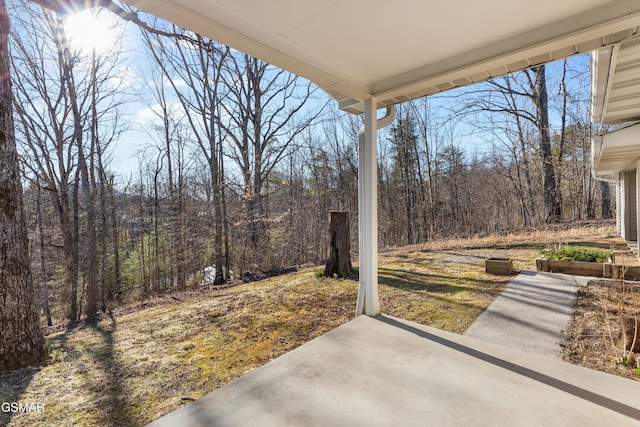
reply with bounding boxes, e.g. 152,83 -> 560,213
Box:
0,271 -> 357,426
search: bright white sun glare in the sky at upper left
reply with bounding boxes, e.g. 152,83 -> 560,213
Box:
65,9 -> 116,53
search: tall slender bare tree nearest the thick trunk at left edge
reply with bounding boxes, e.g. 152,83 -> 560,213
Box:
12,8 -> 78,320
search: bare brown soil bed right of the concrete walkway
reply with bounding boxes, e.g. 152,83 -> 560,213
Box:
563,280 -> 640,381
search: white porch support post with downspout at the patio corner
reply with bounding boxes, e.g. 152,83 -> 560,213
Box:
358,98 -> 380,316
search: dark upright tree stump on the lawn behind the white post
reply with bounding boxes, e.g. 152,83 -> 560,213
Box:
324,211 -> 351,277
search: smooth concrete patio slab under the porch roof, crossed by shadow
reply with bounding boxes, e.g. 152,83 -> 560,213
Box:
151,316 -> 640,427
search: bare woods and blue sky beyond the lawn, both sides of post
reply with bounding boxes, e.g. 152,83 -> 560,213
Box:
9,0 -> 614,324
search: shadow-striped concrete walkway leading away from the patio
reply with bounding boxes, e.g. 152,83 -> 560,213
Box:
465,271 -> 586,360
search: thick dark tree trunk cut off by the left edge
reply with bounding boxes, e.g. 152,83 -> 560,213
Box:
0,0 -> 47,372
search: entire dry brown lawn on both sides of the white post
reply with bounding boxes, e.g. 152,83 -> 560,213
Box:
0,225 -> 612,427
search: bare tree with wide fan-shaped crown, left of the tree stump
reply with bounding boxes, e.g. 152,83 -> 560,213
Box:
221,53 -> 322,268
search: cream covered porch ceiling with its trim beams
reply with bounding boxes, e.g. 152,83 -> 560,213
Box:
125,0 -> 640,113
